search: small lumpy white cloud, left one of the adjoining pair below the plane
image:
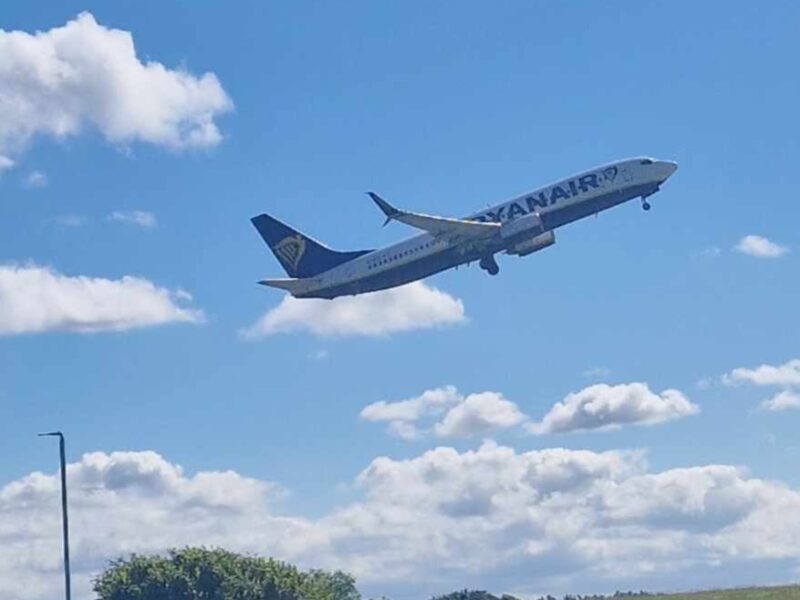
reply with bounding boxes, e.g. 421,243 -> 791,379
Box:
361,385 -> 526,441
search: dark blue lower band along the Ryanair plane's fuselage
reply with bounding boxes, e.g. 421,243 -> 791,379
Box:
302,183 -> 658,298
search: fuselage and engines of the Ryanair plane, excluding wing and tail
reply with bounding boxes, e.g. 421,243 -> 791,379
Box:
255,157 -> 677,298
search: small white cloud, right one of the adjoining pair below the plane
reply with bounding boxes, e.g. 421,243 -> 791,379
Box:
528,383 -> 699,434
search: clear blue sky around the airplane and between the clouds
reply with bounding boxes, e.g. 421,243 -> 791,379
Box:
0,2 -> 800,598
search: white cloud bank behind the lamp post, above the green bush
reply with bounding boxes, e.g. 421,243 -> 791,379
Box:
0,452 -> 314,600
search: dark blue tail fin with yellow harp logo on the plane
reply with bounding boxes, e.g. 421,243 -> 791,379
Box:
250,215 -> 372,277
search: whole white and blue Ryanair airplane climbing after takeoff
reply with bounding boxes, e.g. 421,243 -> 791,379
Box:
251,157 -> 678,299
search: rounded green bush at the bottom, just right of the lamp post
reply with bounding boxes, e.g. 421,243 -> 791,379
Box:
94,548 -> 361,600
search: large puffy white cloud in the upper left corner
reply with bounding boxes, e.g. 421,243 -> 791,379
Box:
0,12 -> 233,168
